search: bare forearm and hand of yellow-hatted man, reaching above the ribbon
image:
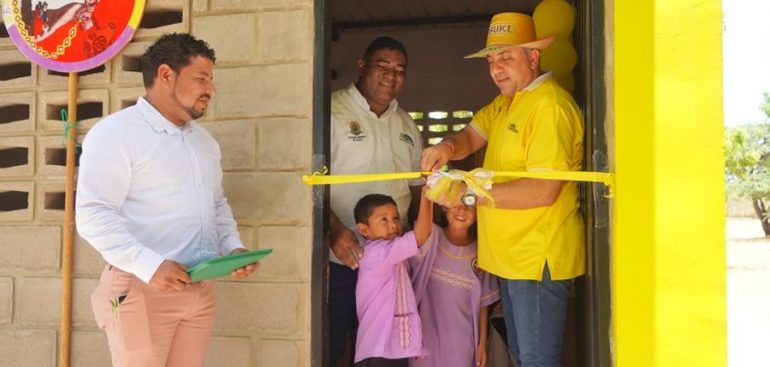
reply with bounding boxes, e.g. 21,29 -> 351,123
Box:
421,127 -> 487,171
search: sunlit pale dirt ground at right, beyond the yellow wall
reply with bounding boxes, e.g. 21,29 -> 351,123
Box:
727,218 -> 770,367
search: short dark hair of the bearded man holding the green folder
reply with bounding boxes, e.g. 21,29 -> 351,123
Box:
142,33 -> 217,88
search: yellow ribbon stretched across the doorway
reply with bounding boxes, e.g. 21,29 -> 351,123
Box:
302,166 -> 615,198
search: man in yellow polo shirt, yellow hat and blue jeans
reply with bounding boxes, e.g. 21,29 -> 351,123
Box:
421,13 -> 585,367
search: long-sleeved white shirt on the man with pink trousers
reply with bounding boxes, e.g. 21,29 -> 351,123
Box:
76,98 -> 243,283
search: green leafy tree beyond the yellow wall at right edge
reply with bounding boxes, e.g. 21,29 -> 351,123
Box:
725,93 -> 770,236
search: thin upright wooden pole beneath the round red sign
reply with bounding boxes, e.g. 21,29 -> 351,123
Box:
59,73 -> 78,367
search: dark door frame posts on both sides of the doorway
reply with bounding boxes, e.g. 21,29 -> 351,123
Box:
310,0 -> 612,367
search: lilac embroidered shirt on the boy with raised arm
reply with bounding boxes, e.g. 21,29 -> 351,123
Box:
355,231 -> 426,362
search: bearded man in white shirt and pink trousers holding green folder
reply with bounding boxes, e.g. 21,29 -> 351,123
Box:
76,34 -> 257,367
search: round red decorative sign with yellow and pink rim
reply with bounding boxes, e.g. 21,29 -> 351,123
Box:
2,0 -> 145,73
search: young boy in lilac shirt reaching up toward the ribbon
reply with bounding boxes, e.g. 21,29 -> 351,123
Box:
354,190 -> 433,367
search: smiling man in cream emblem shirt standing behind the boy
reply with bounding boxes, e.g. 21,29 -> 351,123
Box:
329,37 -> 423,366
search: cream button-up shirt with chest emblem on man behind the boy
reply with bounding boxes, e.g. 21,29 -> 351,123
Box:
329,83 -> 423,264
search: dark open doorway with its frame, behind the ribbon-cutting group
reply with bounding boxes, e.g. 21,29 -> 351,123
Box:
312,0 -> 611,366
